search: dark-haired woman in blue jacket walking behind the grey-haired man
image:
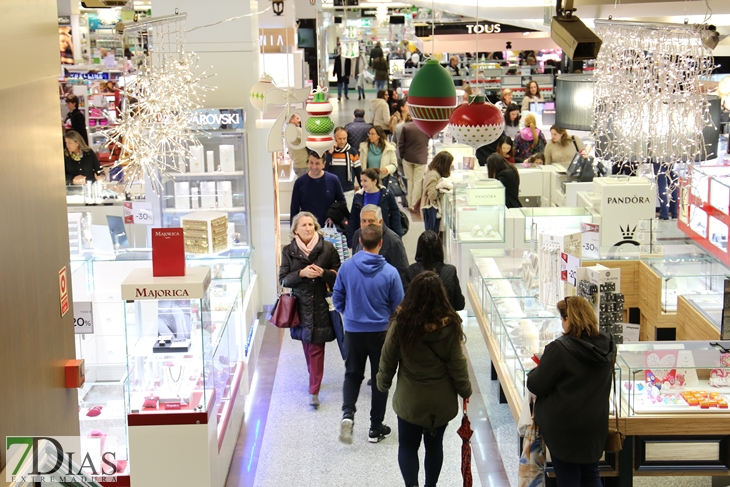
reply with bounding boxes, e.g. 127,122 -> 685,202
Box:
347,168 -> 403,249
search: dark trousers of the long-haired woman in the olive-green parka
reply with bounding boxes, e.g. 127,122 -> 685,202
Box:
398,416 -> 447,487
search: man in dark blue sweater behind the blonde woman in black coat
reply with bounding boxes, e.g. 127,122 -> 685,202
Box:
289,152 -> 346,226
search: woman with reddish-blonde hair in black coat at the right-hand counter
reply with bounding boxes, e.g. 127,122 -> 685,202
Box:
527,296 -> 616,487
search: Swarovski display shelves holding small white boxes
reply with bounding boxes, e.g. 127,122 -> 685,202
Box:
160,109 -> 250,248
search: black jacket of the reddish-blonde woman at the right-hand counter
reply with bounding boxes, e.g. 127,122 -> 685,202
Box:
527,332 -> 616,463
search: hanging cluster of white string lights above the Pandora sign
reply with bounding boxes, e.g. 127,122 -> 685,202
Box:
592,20 -> 714,181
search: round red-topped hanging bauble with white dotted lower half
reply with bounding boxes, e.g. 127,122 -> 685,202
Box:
449,95 -> 504,148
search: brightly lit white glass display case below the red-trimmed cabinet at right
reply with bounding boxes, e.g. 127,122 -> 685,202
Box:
643,255 -> 730,313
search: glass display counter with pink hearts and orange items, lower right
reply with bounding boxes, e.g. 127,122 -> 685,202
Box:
617,341 -> 730,416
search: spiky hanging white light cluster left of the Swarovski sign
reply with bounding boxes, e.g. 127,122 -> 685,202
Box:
104,14 -> 212,194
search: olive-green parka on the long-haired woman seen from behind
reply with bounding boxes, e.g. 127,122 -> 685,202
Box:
377,321 -> 471,428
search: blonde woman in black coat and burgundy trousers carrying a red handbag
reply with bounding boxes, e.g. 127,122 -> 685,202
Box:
279,211 -> 340,408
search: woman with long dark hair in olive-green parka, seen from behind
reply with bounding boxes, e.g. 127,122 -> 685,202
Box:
377,271 -> 471,487
